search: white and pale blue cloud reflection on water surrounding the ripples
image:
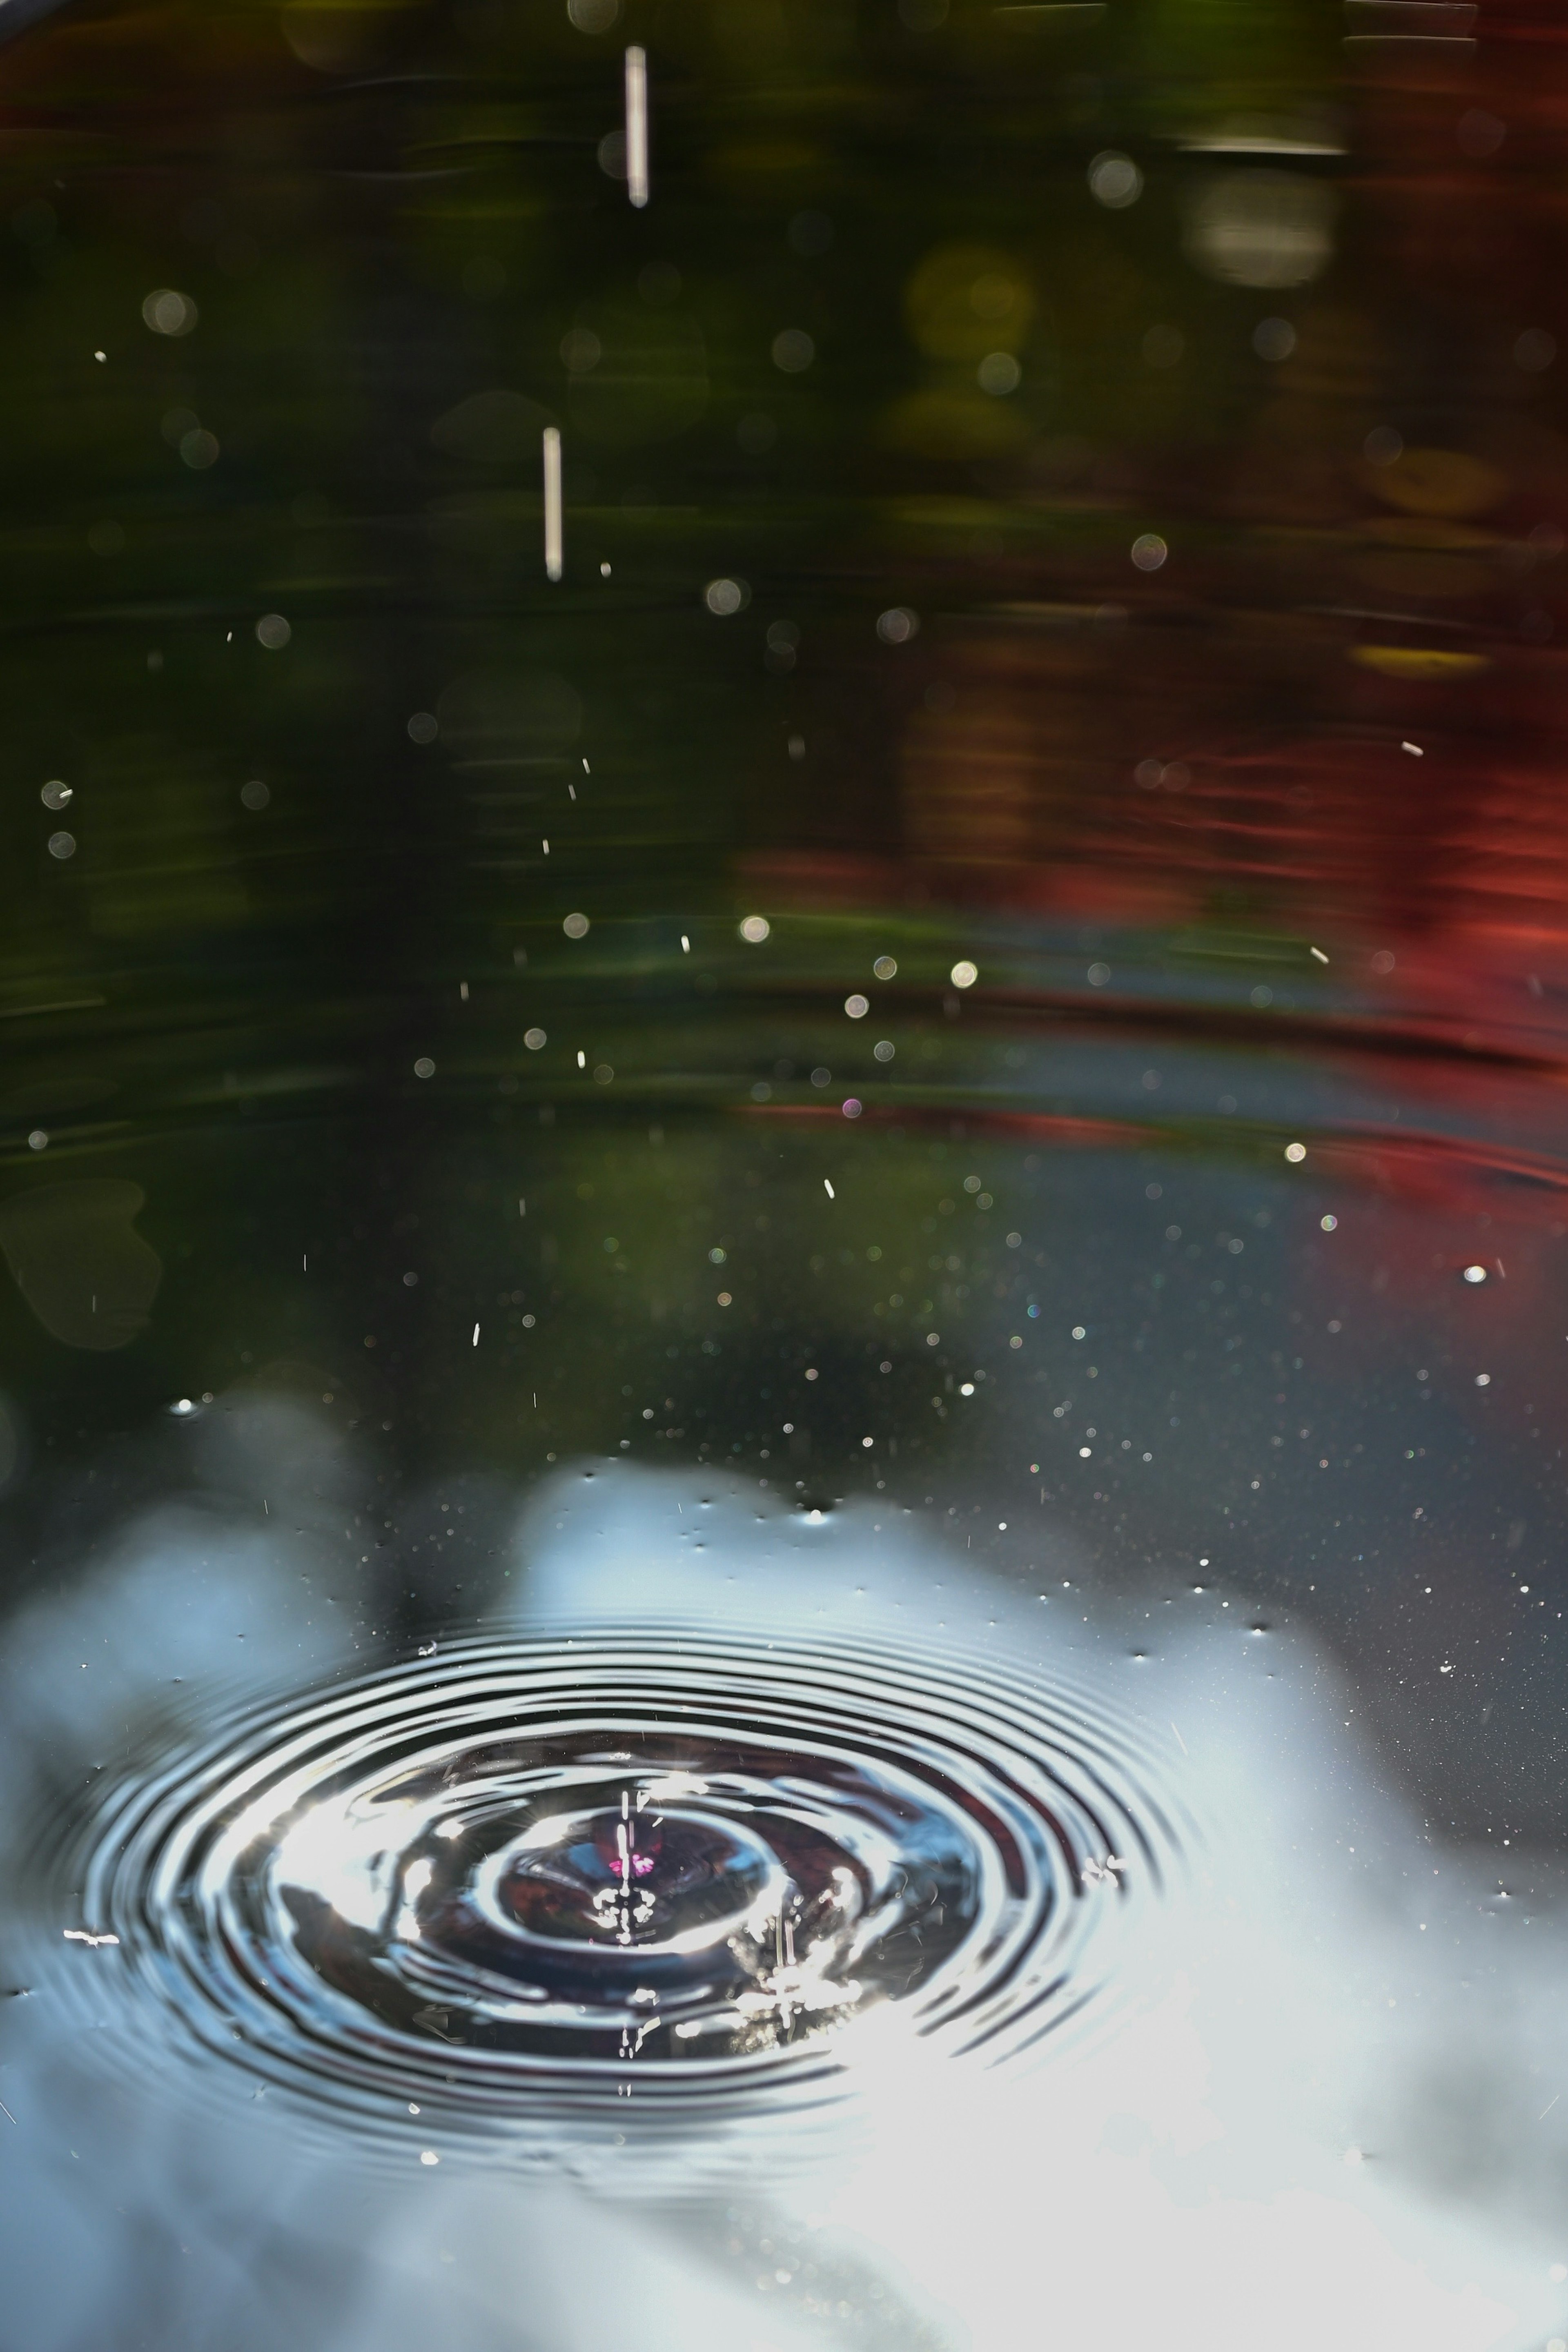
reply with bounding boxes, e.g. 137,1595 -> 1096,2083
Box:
0,1411 -> 1568,2352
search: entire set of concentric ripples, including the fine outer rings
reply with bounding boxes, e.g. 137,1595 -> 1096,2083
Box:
58,1625 -> 1183,2157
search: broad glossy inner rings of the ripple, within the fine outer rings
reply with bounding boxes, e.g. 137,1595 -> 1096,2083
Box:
270,1733 -> 997,2058
